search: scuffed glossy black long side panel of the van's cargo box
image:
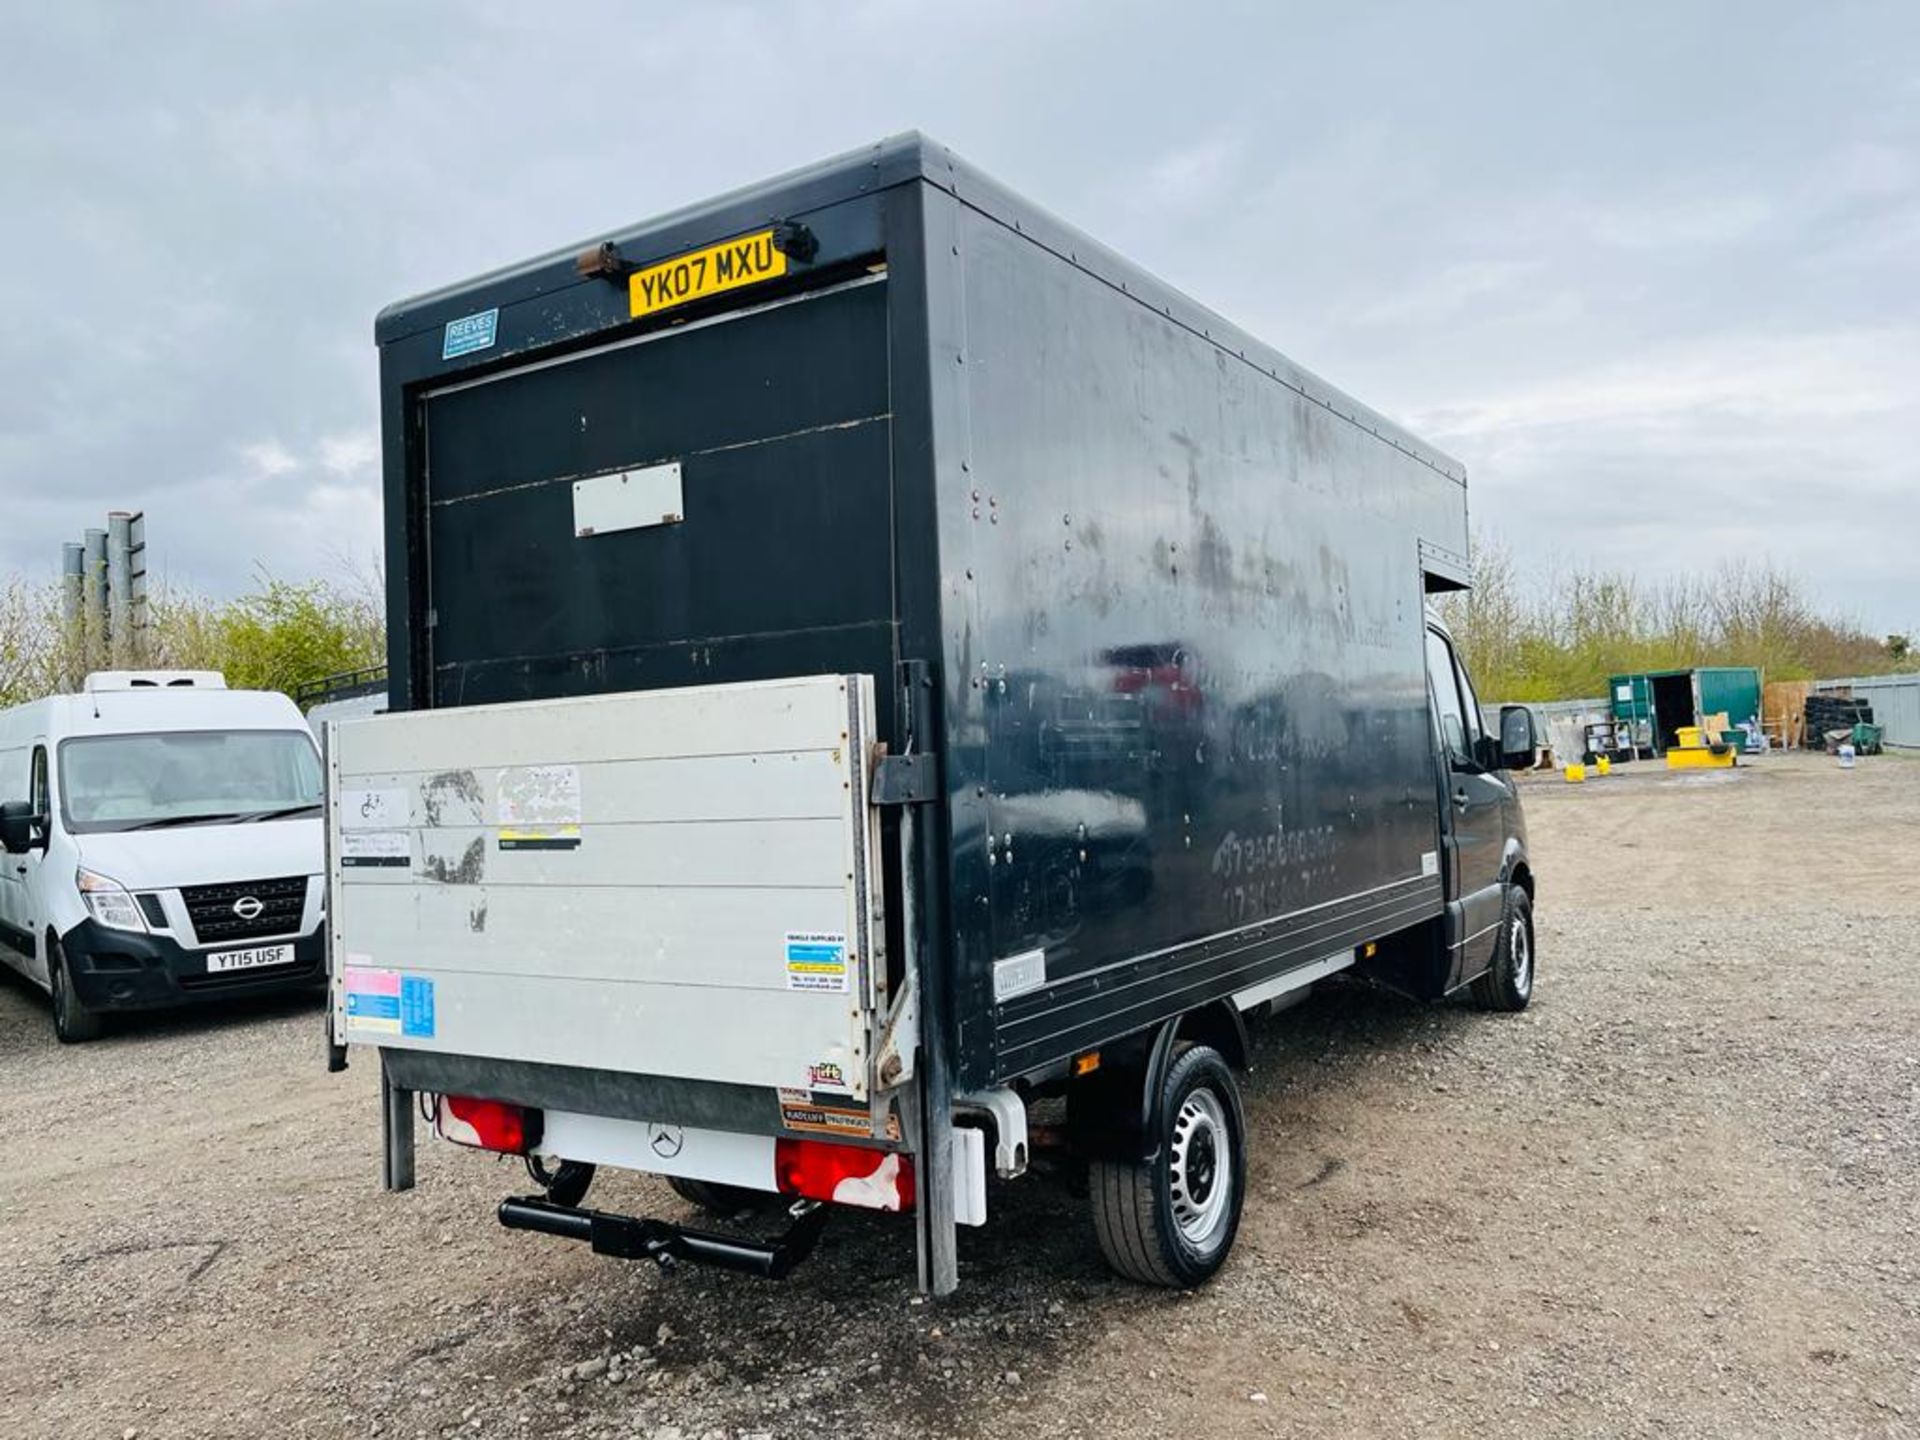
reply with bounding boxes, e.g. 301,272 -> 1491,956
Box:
939,205 -> 1467,1083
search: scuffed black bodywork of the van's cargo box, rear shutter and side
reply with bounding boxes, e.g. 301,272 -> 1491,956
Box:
380,136 -> 1465,1087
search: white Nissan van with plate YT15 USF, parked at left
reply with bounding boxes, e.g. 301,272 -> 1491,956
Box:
0,670 -> 326,1043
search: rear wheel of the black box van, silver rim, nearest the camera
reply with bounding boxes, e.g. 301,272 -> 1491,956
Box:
1087,1044 -> 1246,1290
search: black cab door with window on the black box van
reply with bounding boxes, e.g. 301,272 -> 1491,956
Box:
1427,628 -> 1509,989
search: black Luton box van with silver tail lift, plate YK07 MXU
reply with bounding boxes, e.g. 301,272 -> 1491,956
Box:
328,136 -> 1534,1292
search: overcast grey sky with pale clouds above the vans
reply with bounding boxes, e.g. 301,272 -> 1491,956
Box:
0,0 -> 1920,630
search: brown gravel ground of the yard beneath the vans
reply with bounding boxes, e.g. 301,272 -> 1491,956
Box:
0,756 -> 1920,1440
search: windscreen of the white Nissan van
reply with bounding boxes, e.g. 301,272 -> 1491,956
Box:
60,730 -> 321,835
